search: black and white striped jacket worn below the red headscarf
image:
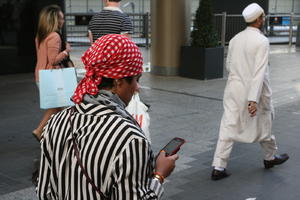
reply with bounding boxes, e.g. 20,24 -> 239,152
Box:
37,103 -> 163,200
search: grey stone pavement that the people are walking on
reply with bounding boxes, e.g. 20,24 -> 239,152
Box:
0,45 -> 300,200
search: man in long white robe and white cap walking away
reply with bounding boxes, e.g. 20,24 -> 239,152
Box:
211,3 -> 289,180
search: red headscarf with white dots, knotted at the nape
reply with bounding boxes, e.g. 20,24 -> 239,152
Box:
72,34 -> 143,104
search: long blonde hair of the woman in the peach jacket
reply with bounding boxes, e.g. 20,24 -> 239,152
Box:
36,5 -> 62,44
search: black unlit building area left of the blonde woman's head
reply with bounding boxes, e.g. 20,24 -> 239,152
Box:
0,0 -> 64,74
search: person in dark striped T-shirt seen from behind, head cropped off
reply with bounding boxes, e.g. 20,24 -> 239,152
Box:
88,0 -> 133,44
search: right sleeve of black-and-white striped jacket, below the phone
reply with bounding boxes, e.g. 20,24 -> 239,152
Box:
112,138 -> 163,200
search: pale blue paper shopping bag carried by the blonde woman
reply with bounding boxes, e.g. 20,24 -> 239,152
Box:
39,67 -> 77,109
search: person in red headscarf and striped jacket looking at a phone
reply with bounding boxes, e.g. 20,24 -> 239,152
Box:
37,34 -> 178,200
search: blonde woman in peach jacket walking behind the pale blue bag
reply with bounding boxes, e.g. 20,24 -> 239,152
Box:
32,5 -> 71,140
